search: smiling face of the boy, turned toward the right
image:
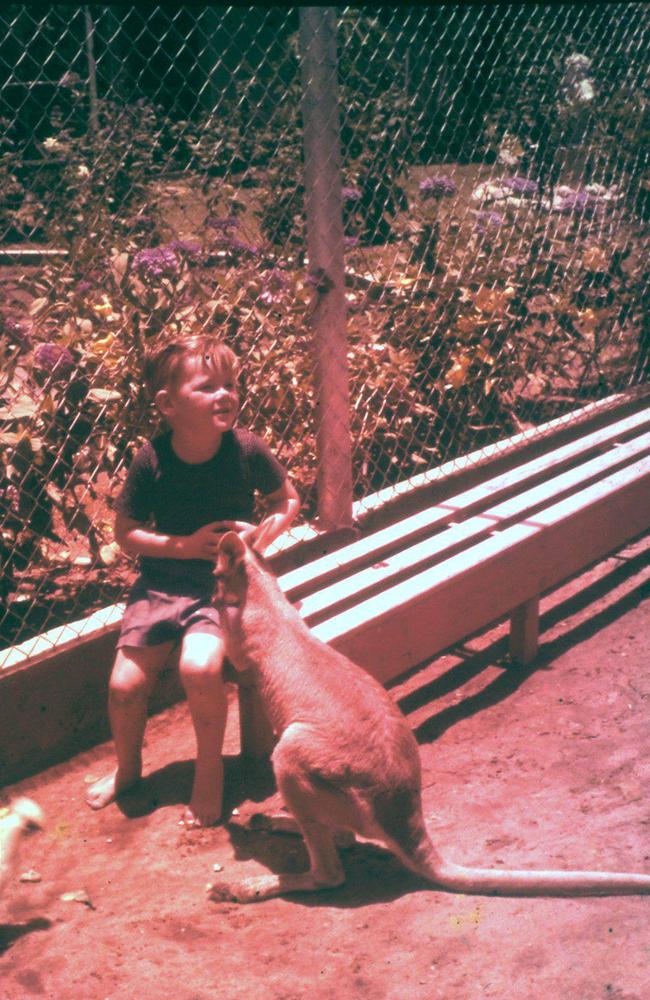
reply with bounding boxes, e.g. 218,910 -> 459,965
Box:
156,358 -> 239,437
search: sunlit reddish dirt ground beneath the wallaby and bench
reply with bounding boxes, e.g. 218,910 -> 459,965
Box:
0,537 -> 650,1000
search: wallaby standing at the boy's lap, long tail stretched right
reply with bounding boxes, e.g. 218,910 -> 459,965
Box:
210,532 -> 650,902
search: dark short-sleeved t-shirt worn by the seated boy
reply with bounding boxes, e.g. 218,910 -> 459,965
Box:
117,428 -> 287,593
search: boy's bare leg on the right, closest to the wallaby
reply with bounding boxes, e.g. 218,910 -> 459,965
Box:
179,631 -> 228,826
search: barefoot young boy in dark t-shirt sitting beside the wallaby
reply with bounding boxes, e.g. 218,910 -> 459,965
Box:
87,334 -> 300,826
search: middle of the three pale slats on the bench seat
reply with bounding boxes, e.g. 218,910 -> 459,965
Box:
292,432 -> 650,625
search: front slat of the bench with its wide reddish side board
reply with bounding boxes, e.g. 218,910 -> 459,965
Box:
313,461 -> 650,681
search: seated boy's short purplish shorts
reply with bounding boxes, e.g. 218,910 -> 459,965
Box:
117,578 -> 223,649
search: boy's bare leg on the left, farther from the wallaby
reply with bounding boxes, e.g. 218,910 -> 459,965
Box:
86,643 -> 172,809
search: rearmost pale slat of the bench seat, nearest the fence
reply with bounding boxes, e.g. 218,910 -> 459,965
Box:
279,407 -> 650,600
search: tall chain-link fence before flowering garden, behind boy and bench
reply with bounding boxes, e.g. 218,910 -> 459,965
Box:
0,3 -> 650,645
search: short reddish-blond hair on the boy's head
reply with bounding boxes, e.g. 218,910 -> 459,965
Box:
144,333 -> 239,397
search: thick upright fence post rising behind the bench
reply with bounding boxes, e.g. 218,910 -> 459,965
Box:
300,7 -> 352,528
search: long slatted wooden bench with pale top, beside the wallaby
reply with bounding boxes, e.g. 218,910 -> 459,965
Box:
234,395 -> 650,754
